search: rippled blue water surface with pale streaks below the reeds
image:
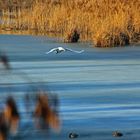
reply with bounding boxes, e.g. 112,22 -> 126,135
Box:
0,35 -> 140,140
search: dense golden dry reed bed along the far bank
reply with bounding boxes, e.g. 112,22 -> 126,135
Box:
1,0 -> 140,47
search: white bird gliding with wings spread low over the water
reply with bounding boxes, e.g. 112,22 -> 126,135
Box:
46,47 -> 84,54
